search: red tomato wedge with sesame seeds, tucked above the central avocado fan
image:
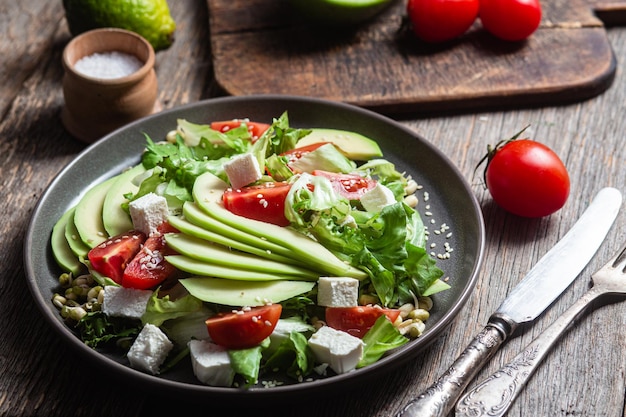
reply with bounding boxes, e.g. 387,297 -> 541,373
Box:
222,182 -> 291,226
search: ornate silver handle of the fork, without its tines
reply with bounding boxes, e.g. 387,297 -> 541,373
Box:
455,287 -> 600,417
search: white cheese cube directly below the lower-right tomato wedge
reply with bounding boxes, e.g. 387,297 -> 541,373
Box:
309,326 -> 363,374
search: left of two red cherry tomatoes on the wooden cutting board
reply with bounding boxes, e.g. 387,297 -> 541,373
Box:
407,0 -> 478,42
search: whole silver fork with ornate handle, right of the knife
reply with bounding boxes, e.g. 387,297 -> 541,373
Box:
455,247 -> 626,417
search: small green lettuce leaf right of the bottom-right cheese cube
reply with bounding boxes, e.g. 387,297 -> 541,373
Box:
356,315 -> 409,368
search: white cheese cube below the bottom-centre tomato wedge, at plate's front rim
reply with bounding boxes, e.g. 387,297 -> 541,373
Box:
187,340 -> 235,387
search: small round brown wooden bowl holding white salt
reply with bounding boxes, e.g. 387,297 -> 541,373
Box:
61,28 -> 158,143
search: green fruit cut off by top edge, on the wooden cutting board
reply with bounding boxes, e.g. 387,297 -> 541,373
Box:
291,0 -> 394,25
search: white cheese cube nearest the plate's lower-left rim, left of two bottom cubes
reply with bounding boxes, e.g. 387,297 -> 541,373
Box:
127,323 -> 174,375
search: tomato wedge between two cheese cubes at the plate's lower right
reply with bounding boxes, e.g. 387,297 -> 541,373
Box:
326,306 -> 400,338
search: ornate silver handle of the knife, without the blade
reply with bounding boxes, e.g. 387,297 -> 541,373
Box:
397,322 -> 510,417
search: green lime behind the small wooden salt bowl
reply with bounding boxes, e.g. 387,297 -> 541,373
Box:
63,0 -> 176,50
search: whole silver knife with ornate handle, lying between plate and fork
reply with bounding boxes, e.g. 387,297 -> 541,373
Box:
398,187 -> 622,417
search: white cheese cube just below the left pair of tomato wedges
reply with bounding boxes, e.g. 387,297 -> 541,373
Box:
102,285 -> 152,319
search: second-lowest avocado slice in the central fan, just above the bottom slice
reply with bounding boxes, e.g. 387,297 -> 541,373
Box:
165,255 -> 317,281
